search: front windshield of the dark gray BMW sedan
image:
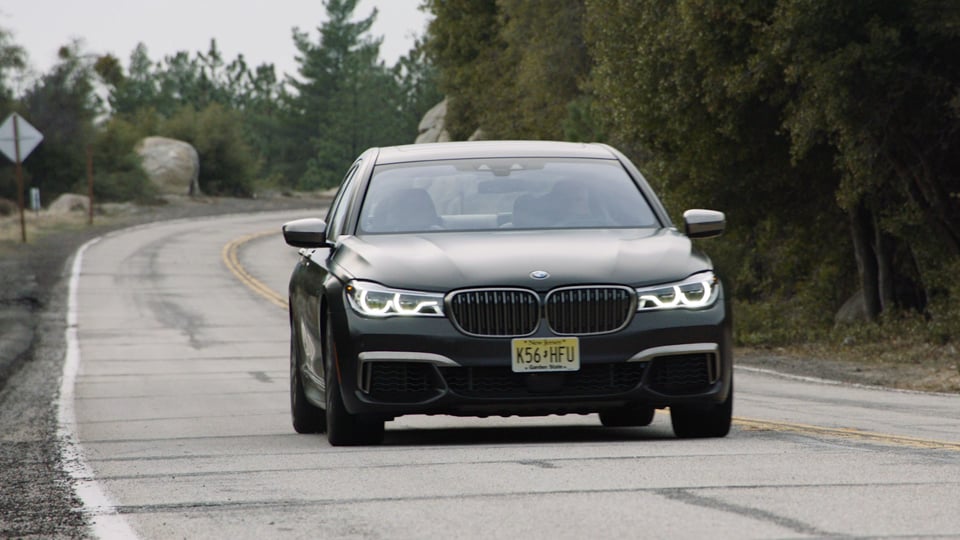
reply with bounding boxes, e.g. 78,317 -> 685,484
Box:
359,158 -> 659,233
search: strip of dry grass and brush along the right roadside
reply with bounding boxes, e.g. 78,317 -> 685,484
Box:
734,290 -> 960,393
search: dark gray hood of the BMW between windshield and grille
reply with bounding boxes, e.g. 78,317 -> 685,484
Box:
331,229 -> 712,292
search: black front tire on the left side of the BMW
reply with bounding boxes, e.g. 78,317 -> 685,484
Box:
323,313 -> 384,446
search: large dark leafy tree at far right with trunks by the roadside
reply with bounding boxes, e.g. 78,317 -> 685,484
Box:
587,0 -> 960,321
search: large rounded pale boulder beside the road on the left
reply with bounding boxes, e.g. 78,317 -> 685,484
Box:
137,137 -> 200,195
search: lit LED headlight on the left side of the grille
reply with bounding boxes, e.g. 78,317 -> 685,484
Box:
346,281 -> 443,317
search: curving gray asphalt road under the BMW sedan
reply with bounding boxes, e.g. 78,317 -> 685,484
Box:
59,211 -> 960,539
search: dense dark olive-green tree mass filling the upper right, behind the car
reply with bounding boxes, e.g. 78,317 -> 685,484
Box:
426,0 -> 960,359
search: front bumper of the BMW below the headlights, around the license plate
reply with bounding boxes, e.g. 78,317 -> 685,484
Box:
326,301 -> 733,418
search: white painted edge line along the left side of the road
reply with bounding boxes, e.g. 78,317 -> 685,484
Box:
57,237 -> 138,539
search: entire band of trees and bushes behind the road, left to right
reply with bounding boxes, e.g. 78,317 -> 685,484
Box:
0,0 -> 960,358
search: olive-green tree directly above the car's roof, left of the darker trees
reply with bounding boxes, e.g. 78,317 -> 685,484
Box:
427,0 -> 595,140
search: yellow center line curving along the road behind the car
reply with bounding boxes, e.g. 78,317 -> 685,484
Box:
221,230 -> 960,451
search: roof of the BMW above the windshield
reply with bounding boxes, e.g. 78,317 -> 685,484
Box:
377,141 -> 616,164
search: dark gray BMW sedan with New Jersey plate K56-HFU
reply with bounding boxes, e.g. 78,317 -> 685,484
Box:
283,141 -> 733,445
